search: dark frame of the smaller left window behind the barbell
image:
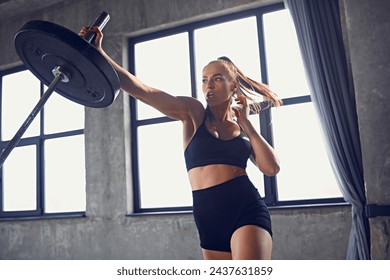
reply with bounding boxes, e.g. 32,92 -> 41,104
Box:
0,65 -> 86,221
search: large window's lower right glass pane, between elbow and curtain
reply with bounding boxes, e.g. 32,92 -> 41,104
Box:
272,103 -> 342,201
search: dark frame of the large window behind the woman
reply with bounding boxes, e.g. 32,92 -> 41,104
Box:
128,3 -> 348,215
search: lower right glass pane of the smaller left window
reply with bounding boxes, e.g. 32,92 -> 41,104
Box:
45,135 -> 86,213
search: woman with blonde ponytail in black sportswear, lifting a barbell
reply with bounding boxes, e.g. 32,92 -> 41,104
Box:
80,27 -> 281,259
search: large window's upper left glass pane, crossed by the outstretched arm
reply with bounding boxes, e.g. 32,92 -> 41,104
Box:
135,33 -> 191,119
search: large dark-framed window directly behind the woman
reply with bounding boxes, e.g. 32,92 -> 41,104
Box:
129,4 -> 343,212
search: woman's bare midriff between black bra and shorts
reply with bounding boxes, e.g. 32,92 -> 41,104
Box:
188,164 -> 246,191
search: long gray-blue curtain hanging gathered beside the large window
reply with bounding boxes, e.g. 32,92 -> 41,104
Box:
285,0 -> 370,259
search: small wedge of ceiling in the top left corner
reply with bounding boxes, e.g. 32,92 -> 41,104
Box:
0,0 -> 65,20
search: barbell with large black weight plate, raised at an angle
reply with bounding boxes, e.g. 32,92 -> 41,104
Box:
0,11 -> 120,168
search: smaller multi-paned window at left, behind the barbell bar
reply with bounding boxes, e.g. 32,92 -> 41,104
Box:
0,67 -> 86,218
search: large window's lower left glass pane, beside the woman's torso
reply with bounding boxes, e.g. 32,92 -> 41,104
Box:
138,121 -> 192,208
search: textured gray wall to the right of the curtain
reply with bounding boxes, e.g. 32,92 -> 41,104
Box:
344,0 -> 390,259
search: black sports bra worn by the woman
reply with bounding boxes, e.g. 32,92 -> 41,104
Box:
184,120 -> 251,171
